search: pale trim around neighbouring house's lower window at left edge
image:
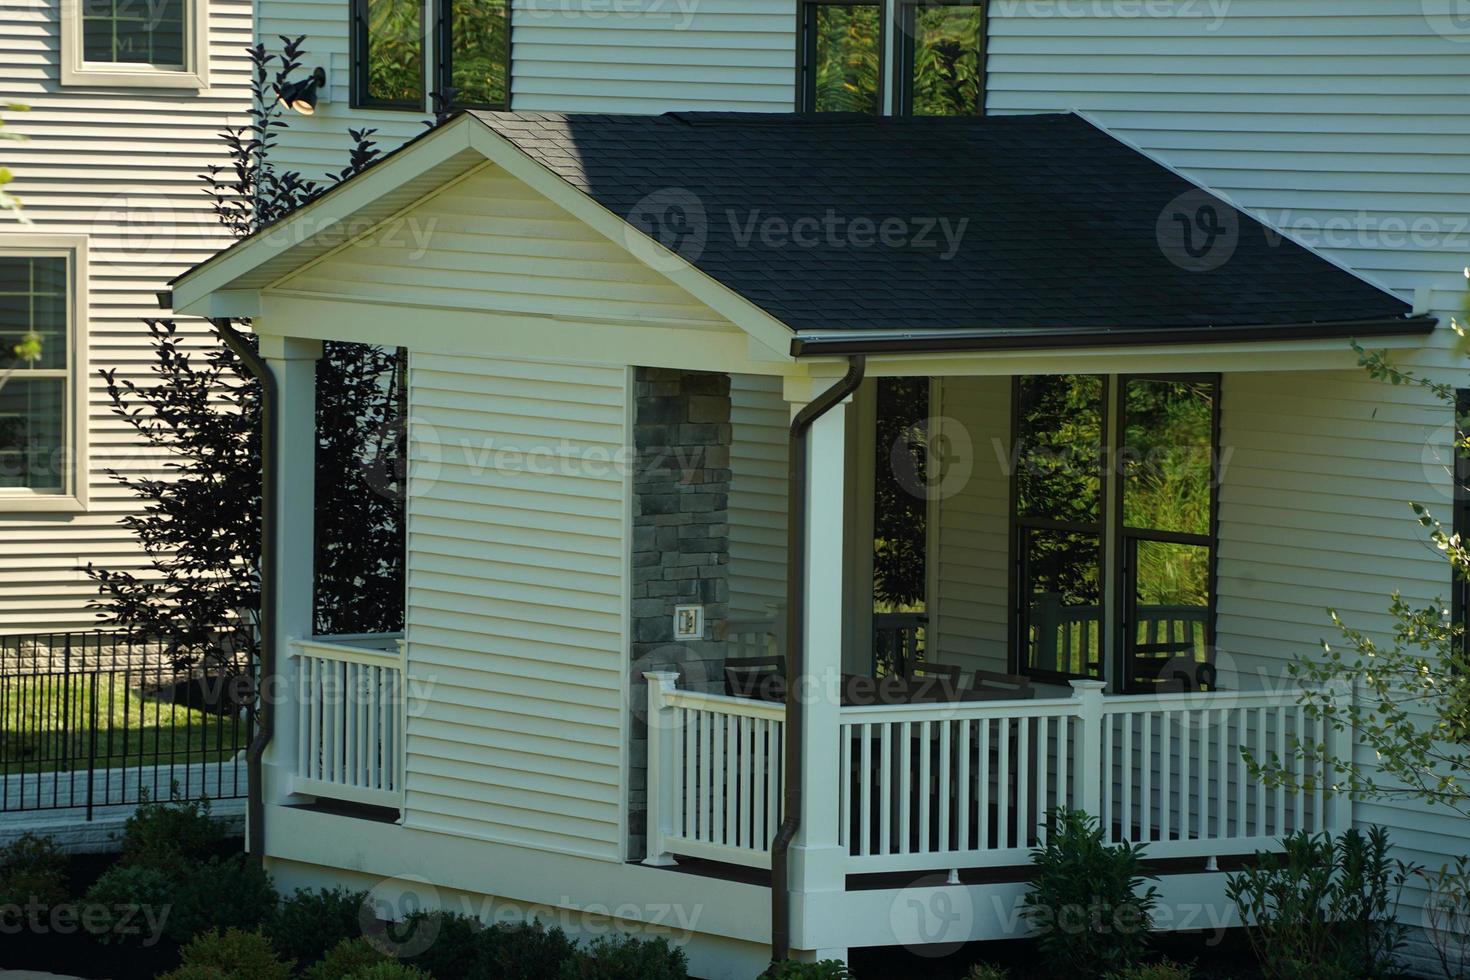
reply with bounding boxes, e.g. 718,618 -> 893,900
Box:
0,232 -> 91,514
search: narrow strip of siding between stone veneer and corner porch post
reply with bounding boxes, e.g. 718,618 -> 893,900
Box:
729,375 -> 791,617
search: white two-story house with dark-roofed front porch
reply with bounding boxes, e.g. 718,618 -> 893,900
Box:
163,0 -> 1470,977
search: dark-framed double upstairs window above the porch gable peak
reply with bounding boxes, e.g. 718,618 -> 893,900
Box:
353,0 -> 510,112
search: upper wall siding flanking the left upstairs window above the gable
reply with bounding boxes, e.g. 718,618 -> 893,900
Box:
257,0 -> 795,178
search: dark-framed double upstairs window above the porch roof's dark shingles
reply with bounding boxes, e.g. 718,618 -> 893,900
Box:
797,0 -> 986,116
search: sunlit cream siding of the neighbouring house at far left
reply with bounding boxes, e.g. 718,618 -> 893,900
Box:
0,0 -> 251,633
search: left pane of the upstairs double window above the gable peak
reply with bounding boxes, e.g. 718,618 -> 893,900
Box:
353,0 -> 425,112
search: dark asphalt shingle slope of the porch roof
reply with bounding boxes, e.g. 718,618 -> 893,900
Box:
475,112 -> 1410,336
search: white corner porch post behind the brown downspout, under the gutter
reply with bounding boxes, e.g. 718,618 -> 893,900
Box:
791,387 -> 848,922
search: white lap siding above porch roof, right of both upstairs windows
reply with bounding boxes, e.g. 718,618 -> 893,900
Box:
988,0 -> 1470,310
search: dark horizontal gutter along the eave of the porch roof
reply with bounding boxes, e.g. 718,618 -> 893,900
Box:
791,316 -> 1439,357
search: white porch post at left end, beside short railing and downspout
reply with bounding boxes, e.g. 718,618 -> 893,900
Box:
260,335 -> 322,804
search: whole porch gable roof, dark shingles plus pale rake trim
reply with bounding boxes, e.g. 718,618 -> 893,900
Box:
173,112 -> 1435,356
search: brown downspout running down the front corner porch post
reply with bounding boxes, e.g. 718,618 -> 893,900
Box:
770,354 -> 867,962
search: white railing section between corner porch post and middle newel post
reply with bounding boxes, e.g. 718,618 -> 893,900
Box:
838,698 -> 1095,874
